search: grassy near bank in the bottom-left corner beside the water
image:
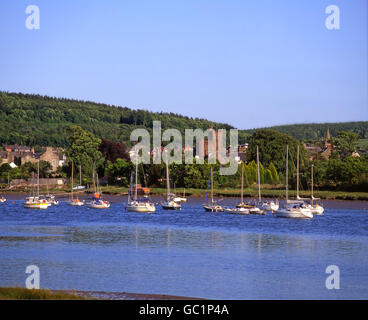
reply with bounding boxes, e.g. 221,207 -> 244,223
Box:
0,287 -> 85,300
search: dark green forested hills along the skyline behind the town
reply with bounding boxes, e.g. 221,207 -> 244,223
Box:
0,91 -> 368,147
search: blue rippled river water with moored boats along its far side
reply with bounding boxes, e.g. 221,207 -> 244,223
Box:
0,198 -> 368,299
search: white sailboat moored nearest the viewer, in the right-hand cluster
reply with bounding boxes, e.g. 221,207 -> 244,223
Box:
275,145 -> 313,219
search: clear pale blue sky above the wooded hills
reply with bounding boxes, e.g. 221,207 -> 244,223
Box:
0,0 -> 368,129
